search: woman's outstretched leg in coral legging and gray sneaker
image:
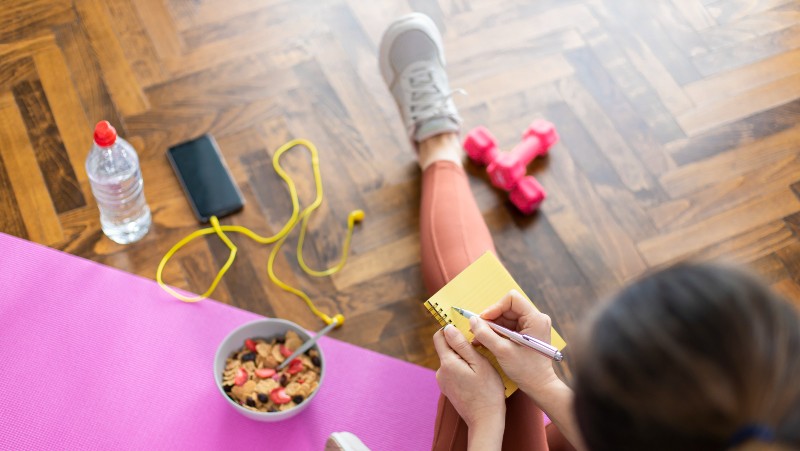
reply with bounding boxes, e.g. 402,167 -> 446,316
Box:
378,13 -> 547,450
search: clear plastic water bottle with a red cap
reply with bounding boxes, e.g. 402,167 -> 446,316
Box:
86,121 -> 152,244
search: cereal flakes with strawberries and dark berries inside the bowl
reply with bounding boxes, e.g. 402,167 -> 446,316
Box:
222,330 -> 322,412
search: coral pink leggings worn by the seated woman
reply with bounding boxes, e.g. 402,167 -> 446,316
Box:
420,161 -> 563,451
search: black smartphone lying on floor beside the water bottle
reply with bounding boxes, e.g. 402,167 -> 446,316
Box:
167,135 -> 244,223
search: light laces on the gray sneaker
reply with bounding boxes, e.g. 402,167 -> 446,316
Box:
408,66 -> 467,124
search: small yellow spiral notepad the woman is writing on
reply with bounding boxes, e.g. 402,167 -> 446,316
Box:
425,252 -> 567,397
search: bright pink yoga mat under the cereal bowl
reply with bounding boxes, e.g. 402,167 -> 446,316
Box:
0,234 -> 439,450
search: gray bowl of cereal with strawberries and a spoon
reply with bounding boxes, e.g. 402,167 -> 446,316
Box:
214,318 -> 325,421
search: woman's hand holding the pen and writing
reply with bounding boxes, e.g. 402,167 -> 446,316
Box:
470,290 -> 561,401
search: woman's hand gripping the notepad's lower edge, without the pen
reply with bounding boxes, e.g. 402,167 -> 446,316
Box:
433,325 -> 506,448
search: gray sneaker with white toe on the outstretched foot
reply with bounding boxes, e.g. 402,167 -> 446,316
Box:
379,13 -> 463,143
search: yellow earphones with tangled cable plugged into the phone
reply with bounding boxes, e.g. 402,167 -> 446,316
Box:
156,139 -> 364,327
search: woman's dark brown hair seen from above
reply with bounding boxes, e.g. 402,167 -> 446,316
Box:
574,263 -> 800,451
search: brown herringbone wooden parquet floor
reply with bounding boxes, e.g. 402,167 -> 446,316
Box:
0,0 -> 800,374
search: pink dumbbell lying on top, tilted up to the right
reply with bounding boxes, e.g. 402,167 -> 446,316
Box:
486,119 -> 558,191
